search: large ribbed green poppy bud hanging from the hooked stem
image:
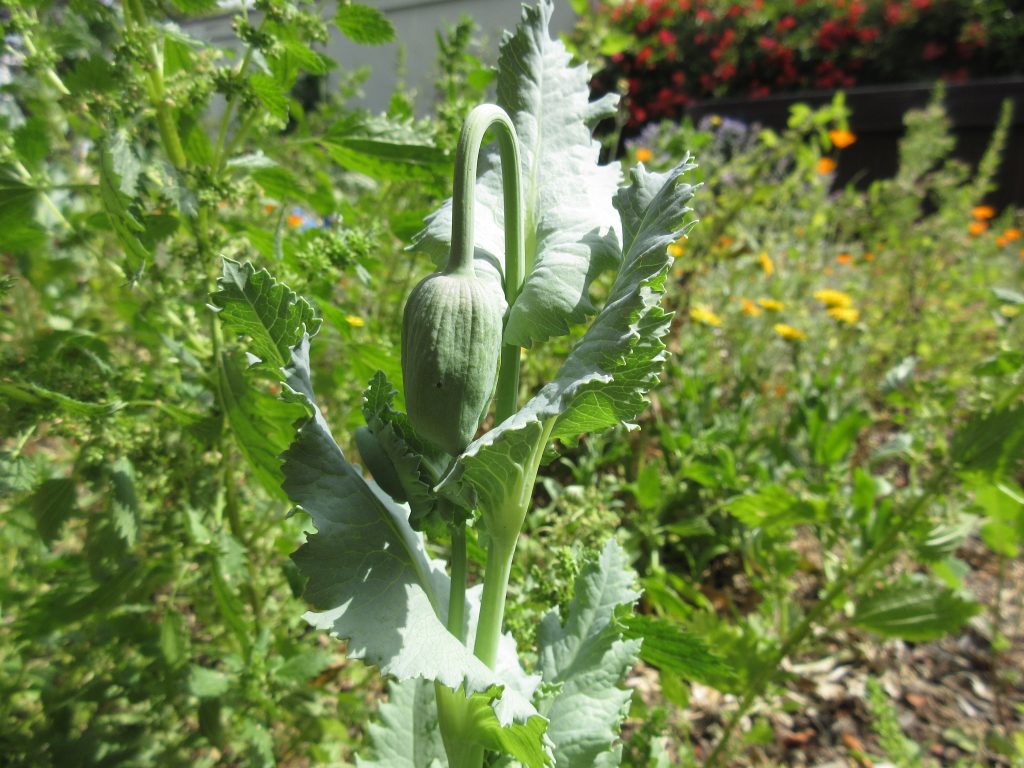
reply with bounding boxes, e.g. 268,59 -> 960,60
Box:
401,265 -> 506,456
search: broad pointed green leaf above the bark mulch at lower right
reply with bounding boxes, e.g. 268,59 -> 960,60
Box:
853,575 -> 981,642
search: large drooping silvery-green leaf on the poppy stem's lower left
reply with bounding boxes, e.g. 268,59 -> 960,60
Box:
284,337 -> 550,768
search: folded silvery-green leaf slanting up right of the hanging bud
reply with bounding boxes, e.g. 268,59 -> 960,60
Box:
444,161 -> 693,515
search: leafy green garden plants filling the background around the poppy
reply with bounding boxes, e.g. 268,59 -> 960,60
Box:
0,1 -> 1024,766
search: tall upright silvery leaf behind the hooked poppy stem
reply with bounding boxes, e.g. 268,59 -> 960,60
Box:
416,0 -> 622,346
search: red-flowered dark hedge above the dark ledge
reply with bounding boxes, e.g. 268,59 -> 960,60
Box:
581,0 -> 1024,129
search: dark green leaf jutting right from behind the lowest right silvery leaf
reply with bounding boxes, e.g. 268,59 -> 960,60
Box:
620,615 -> 733,686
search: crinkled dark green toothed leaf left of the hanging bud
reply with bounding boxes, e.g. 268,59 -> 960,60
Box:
210,259 -> 322,375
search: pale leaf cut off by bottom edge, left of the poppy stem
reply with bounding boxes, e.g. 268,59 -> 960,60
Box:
355,679 -> 447,768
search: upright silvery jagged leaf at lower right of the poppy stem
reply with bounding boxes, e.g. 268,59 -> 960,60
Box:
537,540 -> 640,768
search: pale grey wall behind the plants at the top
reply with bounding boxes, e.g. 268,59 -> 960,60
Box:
183,0 -> 575,115
